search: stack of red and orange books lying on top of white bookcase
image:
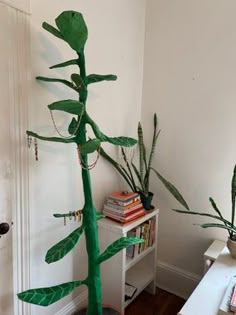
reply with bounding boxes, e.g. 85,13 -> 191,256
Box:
103,190 -> 146,223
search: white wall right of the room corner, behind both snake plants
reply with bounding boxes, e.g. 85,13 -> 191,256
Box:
142,0 -> 236,298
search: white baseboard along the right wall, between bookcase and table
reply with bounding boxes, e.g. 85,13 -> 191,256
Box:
156,261 -> 201,300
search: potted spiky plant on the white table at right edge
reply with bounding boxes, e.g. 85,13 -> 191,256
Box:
173,165 -> 236,258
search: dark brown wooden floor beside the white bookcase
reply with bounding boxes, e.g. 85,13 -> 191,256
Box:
125,288 -> 185,315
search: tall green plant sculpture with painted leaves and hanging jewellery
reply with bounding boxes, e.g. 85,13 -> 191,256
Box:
18,11 -> 143,315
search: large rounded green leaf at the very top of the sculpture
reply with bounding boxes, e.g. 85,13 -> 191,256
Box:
55,11 -> 88,52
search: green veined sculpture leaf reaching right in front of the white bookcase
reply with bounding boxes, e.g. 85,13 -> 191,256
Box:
97,237 -> 144,264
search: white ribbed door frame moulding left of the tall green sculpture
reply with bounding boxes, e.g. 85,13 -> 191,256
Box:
0,0 -> 31,315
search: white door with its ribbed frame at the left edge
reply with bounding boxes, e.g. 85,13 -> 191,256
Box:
0,0 -> 30,315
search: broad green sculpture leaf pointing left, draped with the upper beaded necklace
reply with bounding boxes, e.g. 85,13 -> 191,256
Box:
48,100 -> 84,115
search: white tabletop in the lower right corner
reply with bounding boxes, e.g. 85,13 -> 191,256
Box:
178,247 -> 236,315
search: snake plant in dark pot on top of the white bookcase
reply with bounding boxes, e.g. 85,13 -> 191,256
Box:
100,113 -> 187,210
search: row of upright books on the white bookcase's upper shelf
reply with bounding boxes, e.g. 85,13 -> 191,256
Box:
126,219 -> 156,258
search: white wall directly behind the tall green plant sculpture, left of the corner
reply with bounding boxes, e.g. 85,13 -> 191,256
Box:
29,0 -> 146,315
